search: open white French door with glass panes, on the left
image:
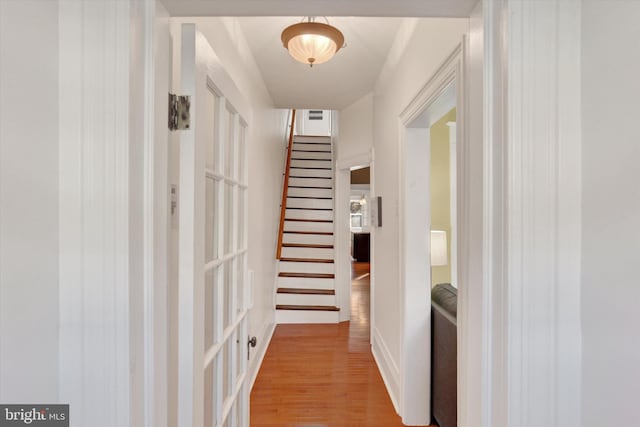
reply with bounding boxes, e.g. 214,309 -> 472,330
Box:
178,24 -> 249,427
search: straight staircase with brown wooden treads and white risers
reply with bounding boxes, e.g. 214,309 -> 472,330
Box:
276,136 -> 340,323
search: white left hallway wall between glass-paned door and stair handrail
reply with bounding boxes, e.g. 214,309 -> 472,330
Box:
170,18 -> 287,398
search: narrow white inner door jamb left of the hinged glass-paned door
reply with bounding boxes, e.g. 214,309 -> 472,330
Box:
141,0 -> 171,427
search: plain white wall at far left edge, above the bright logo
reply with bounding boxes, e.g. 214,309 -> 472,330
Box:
0,0 -> 58,403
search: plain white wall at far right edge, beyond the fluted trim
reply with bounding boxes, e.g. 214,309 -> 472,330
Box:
582,0 -> 640,427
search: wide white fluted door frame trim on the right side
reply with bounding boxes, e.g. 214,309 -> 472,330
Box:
482,0 -> 582,427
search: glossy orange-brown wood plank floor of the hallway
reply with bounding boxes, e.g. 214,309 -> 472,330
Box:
251,263 -> 430,427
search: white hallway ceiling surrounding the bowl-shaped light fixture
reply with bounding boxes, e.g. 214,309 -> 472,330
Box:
238,17 -> 403,110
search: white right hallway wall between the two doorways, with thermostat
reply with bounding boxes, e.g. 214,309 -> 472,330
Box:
372,19 -> 469,399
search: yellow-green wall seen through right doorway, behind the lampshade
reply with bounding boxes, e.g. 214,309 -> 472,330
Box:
430,108 -> 456,285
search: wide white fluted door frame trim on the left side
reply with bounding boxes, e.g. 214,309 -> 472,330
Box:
58,0 -> 143,427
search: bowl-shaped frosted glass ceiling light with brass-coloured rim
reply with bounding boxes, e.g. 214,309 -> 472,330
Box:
281,17 -> 344,67
